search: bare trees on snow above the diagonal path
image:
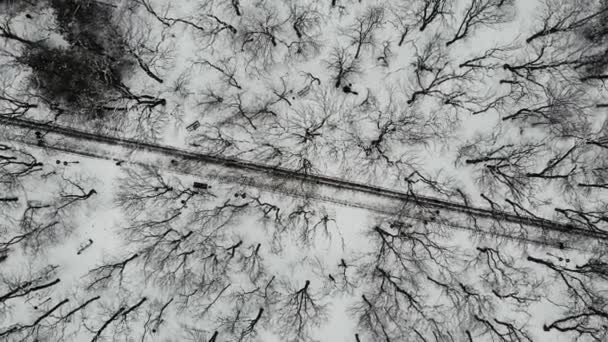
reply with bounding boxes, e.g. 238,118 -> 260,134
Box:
2,0 -> 604,206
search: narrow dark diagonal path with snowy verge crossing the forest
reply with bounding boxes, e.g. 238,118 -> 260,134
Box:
0,116 -> 608,247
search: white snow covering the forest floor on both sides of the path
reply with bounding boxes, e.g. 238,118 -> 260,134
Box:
0,0 -> 608,342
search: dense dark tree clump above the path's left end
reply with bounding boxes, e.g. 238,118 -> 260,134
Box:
1,0 -> 170,137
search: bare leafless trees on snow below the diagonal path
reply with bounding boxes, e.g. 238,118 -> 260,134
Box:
0,154 -> 608,341
